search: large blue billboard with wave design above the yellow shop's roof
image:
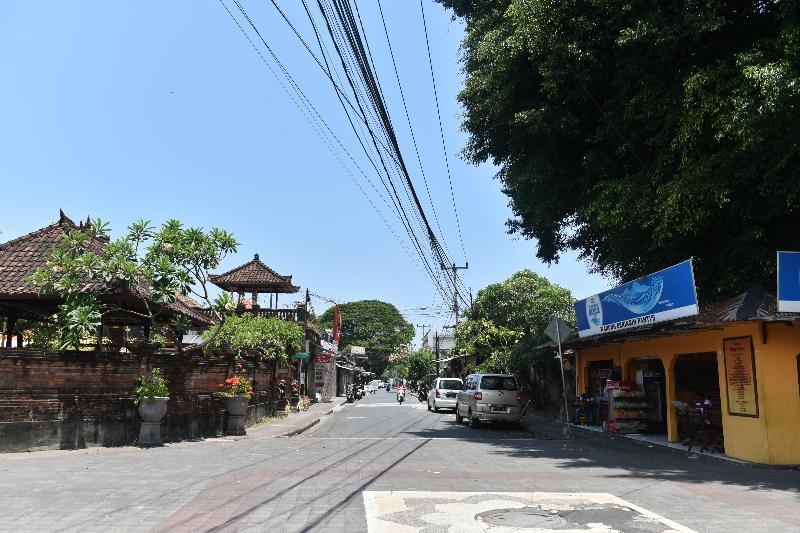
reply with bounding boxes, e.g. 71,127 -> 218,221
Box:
575,259 -> 699,337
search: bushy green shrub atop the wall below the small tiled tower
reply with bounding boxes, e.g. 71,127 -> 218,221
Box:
203,315 -> 303,362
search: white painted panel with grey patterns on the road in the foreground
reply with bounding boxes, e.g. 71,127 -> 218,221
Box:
361,491 -> 697,533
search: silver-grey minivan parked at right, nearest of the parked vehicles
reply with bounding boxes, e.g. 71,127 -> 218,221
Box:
456,374 -> 522,428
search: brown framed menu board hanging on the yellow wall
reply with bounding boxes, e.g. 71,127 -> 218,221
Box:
722,337 -> 758,418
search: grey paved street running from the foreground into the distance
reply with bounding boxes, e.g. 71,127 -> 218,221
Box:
0,390 -> 800,533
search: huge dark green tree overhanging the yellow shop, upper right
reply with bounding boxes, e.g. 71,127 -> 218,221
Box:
438,0 -> 800,299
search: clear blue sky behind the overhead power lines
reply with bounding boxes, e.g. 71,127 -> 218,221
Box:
0,0 -> 608,342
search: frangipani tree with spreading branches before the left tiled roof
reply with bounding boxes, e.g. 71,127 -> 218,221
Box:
30,219 -> 237,347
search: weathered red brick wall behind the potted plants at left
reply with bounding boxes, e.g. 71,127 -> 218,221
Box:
0,349 -> 285,452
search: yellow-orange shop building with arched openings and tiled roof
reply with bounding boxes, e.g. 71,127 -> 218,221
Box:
570,288 -> 800,465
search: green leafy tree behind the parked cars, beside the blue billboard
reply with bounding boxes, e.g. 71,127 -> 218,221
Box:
455,269 -> 575,375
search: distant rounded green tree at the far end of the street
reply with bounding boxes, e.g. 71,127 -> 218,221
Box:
317,300 -> 414,375
